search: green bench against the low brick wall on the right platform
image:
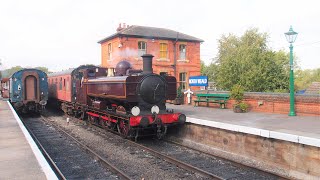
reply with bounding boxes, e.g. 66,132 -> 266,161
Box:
194,94 -> 230,109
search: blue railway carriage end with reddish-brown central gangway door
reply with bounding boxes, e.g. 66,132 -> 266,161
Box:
10,69 -> 48,113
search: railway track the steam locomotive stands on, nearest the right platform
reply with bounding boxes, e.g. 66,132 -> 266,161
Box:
43,110 -> 280,179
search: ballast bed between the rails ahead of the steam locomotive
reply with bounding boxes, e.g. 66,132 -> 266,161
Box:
139,139 -> 280,180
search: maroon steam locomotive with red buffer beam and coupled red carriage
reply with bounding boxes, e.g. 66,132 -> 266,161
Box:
48,54 -> 186,140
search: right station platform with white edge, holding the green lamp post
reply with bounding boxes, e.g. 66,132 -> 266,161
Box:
167,104 -> 320,147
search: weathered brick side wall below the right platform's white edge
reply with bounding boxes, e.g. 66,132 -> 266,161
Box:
168,123 -> 320,179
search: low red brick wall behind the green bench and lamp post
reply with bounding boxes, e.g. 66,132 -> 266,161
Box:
192,91 -> 320,116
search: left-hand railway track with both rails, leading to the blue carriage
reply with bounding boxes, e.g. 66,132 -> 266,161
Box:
22,114 -> 130,179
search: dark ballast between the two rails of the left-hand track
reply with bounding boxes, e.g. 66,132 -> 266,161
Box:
23,114 -> 118,179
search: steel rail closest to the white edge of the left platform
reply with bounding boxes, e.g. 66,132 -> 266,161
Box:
22,118 -> 66,180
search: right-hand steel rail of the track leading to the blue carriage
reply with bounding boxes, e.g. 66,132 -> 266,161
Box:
41,116 -> 131,180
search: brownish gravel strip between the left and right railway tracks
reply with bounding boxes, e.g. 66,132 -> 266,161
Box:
43,109 -> 206,179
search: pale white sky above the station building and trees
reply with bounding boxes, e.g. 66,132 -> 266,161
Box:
0,0 -> 320,71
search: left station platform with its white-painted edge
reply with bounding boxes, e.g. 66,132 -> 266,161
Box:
0,99 -> 58,180
